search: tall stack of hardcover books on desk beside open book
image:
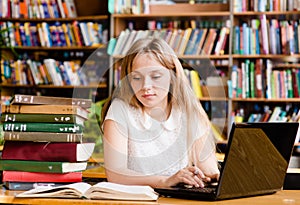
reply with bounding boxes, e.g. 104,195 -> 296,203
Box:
0,95 -> 95,190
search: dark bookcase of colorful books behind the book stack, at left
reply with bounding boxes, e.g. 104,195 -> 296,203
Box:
0,0 -> 110,101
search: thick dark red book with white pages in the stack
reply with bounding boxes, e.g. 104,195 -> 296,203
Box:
2,141 -> 95,162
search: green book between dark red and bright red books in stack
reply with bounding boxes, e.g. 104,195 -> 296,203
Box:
0,160 -> 87,173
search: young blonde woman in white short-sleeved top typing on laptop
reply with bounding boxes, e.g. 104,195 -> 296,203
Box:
102,38 -> 219,187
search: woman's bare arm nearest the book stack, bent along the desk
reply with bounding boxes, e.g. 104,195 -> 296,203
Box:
103,120 -> 204,187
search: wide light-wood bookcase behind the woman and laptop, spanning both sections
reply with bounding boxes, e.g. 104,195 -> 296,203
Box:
109,0 -> 300,145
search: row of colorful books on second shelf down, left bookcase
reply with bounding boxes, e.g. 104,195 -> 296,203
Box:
0,21 -> 108,47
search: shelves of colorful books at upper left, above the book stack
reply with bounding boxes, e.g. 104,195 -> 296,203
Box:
0,0 -> 110,101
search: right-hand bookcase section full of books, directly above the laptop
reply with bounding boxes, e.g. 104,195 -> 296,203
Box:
228,0 -> 300,135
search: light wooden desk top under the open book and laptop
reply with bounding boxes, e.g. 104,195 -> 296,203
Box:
0,190 -> 300,205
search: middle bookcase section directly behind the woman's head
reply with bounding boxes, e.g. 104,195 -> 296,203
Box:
108,1 -> 230,139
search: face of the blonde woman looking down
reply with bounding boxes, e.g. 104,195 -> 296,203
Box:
129,54 -> 171,110
